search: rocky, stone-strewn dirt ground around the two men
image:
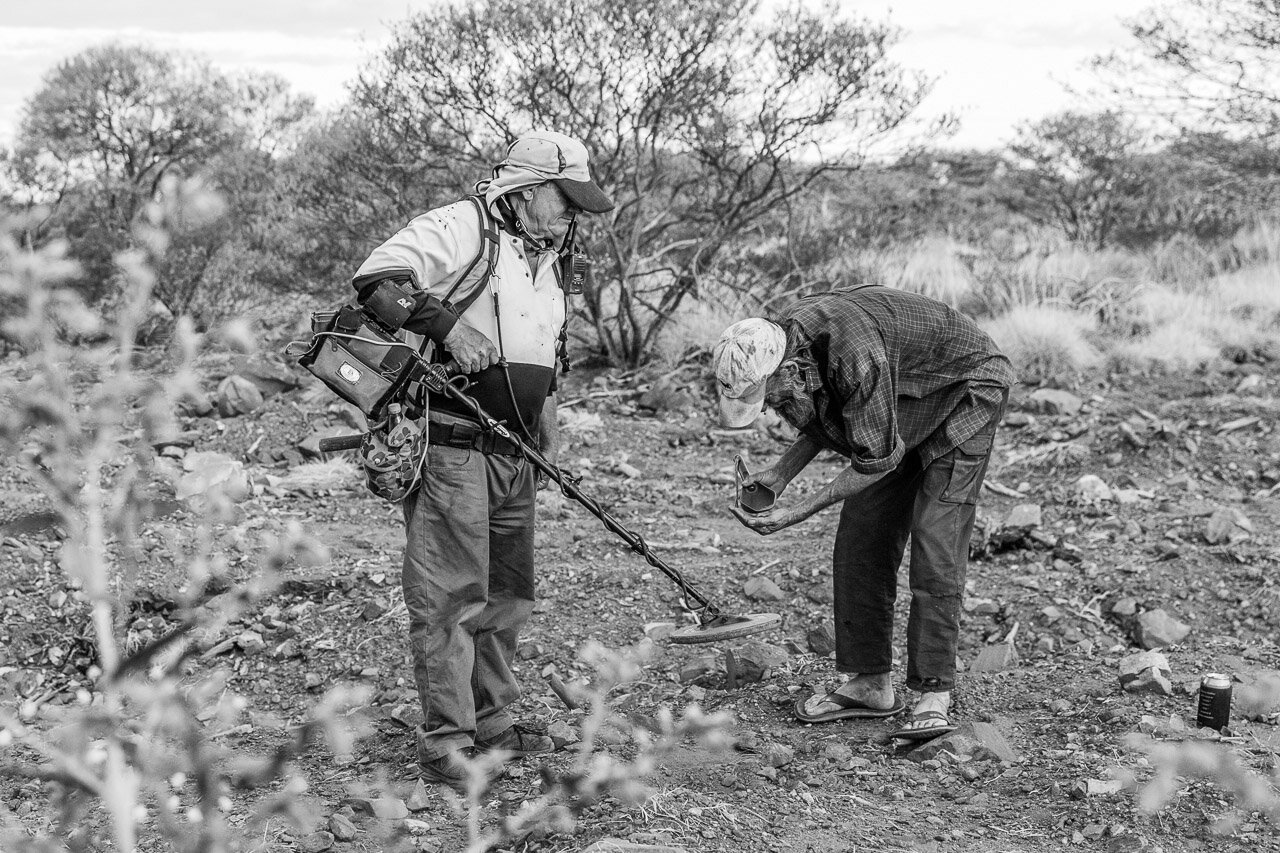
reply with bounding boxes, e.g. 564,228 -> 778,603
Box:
0,350 -> 1280,853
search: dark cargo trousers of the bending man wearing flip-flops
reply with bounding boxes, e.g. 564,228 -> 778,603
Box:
833,412 -> 1000,692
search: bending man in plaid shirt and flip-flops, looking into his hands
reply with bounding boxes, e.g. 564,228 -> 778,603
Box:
712,286 -> 1014,740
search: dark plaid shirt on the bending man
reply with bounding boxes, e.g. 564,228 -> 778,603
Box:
780,286 -> 1015,474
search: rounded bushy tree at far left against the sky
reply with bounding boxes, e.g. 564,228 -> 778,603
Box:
4,45 -> 311,322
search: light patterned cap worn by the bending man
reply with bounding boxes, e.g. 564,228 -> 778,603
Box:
712,316 -> 787,429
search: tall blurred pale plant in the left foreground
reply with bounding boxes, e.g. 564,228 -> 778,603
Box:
0,206 -> 351,853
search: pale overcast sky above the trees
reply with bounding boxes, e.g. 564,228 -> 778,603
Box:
0,0 -> 1151,147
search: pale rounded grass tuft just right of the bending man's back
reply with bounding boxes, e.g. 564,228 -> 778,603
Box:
983,305 -> 1100,382
